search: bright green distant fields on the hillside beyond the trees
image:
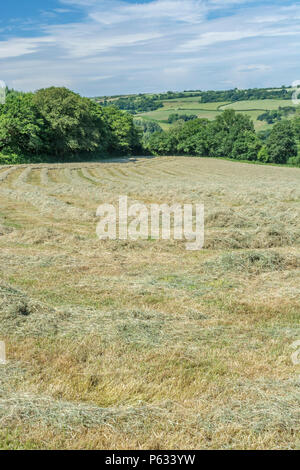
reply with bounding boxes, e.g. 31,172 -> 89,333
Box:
137,96 -> 292,131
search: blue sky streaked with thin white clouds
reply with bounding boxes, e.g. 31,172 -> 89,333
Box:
0,0 -> 300,96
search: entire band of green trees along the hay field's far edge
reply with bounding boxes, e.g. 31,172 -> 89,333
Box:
0,87 -> 300,165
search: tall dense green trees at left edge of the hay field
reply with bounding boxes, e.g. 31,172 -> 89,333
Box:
0,87 -> 141,163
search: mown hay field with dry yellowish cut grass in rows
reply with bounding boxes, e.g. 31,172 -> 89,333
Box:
0,157 -> 300,449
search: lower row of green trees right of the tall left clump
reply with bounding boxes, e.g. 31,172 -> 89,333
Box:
146,109 -> 300,165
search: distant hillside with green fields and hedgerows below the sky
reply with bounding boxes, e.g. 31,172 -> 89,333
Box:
93,86 -> 295,131
